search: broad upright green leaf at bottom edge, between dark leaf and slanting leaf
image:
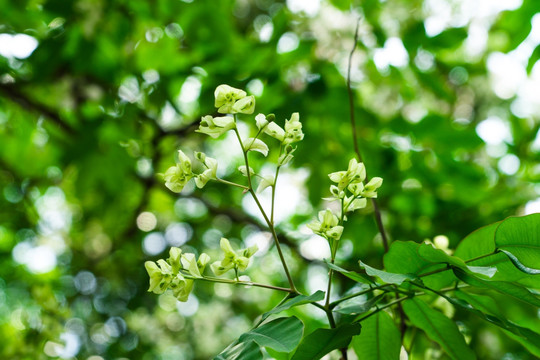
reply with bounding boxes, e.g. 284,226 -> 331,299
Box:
352,311 -> 401,360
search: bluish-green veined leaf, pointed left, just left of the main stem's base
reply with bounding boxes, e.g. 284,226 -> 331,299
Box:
239,316 -> 304,352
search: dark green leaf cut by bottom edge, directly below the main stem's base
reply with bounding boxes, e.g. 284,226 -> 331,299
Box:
292,323 -> 362,360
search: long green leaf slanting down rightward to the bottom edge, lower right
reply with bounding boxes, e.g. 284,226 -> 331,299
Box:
403,298 -> 476,360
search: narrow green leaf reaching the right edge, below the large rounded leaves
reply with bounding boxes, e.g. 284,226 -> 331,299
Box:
452,268 -> 540,307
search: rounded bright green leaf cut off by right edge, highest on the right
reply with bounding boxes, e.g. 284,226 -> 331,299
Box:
495,214 -> 540,273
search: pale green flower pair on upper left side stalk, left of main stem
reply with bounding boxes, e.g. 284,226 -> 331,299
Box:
163,150 -> 218,193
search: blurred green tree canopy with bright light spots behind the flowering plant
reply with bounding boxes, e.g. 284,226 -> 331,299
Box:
0,0 -> 540,360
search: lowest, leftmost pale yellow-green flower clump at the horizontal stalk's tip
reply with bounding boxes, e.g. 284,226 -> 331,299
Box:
144,247 -> 210,301
